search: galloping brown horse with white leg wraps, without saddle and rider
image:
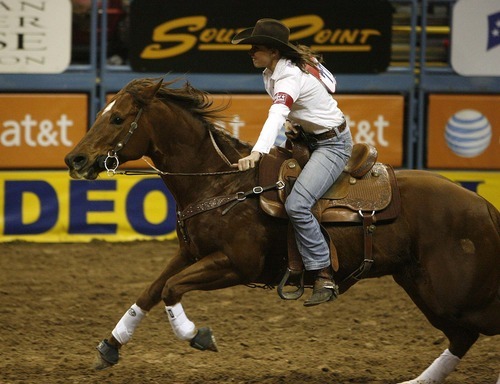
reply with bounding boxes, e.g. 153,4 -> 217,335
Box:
65,79 -> 500,383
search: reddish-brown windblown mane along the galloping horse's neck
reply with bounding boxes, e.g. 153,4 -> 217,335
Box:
126,78 -> 251,151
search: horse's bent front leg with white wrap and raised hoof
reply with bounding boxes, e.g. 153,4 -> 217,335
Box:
162,252 -> 242,352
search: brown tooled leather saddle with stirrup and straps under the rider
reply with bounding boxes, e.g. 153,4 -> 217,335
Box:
259,138 -> 400,299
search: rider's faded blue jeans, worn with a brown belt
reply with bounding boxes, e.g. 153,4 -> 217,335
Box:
285,127 -> 353,271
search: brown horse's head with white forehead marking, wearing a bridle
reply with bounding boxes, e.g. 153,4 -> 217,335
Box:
64,79 -> 162,180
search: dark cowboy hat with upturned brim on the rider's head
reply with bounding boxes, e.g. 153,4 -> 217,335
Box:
231,19 -> 298,52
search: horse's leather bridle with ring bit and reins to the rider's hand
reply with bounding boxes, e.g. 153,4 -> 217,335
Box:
104,108 -> 240,177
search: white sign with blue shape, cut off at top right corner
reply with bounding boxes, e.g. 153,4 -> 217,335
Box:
451,0 -> 500,76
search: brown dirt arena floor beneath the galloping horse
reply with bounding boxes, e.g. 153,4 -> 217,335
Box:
0,241 -> 500,384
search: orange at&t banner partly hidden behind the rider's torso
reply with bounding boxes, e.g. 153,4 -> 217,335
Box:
212,95 -> 404,167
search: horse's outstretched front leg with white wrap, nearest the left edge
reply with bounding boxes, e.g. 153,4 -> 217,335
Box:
94,252 -> 189,370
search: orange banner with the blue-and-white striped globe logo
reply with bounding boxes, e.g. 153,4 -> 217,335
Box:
427,95 -> 500,169
